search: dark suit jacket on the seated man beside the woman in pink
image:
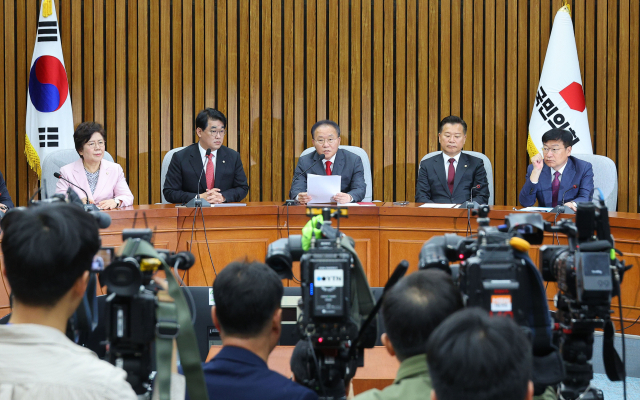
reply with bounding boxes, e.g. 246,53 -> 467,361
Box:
163,143 -> 249,203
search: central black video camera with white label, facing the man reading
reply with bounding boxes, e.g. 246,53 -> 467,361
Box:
266,208 -> 377,400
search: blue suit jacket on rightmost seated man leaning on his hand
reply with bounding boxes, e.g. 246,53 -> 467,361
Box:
519,156 -> 593,207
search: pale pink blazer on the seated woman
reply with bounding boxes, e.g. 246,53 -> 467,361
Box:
56,159 -> 133,207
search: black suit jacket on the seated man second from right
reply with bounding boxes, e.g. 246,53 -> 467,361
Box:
416,152 -> 489,204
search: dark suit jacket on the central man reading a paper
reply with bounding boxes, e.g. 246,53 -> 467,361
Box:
289,149 -> 367,202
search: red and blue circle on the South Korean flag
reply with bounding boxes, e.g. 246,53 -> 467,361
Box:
29,56 -> 69,113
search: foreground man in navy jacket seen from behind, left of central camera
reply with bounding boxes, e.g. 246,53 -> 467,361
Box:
195,261 -> 318,400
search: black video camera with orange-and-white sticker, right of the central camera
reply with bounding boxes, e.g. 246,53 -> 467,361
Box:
418,206 -> 544,326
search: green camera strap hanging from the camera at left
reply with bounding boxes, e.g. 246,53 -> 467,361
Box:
125,240 -> 209,400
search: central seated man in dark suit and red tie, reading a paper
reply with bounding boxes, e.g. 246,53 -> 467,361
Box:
289,120 -> 367,204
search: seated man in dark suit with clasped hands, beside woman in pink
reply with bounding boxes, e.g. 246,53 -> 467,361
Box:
163,108 -> 249,204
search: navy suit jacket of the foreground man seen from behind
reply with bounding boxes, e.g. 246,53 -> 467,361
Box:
186,346 -> 318,400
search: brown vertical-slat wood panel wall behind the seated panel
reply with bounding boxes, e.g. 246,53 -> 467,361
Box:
0,0 -> 640,212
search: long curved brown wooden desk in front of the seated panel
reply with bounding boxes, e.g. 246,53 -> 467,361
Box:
0,203 -> 640,334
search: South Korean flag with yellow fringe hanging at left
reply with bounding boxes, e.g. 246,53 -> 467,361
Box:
25,0 -> 75,177
